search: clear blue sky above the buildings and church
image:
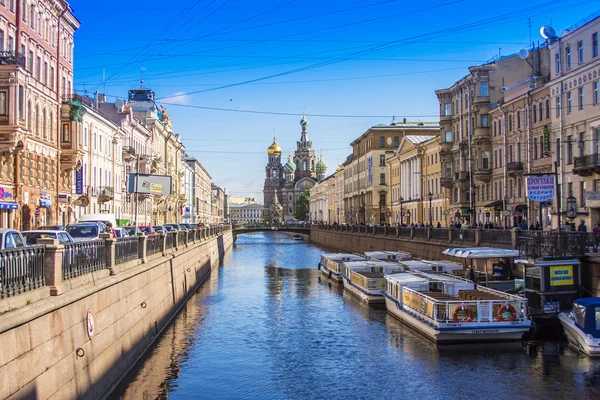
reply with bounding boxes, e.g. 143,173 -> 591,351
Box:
70,0 -> 600,199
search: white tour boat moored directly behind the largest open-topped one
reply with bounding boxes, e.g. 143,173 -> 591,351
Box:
342,261 -> 404,304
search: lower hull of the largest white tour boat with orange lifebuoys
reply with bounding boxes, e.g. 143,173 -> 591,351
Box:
385,296 -> 530,344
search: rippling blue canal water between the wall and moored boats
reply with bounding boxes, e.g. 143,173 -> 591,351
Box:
110,233 -> 600,400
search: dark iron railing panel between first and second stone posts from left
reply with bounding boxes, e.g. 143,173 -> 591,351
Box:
62,240 -> 106,280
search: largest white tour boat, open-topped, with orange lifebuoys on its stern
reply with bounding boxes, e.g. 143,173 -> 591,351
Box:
384,272 -> 531,343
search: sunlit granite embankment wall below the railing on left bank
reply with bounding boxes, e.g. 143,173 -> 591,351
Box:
0,230 -> 233,399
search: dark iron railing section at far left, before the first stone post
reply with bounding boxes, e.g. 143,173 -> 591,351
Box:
0,246 -> 46,299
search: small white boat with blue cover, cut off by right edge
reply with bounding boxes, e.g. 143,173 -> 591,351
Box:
558,297 -> 600,357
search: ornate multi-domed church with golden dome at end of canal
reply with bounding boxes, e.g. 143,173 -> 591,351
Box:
263,115 -> 327,223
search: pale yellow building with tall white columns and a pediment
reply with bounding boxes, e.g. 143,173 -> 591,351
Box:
386,135 -> 449,226
